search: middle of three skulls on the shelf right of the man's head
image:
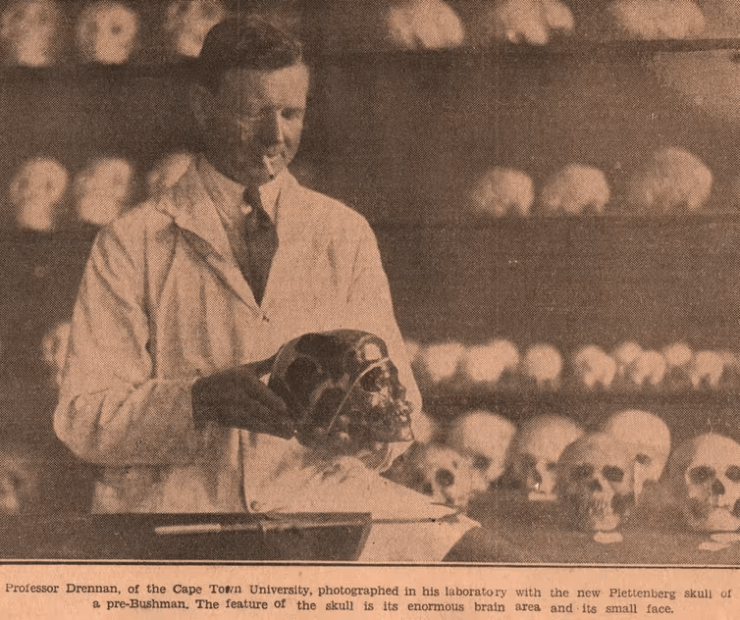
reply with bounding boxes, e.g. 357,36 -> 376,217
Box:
540,164 -> 611,215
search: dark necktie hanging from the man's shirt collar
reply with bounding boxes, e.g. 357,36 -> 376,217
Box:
244,189 -> 278,304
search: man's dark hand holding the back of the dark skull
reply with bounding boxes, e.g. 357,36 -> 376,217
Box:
192,357 -> 295,439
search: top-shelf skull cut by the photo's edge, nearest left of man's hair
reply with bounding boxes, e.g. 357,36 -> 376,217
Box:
164,0 -> 227,57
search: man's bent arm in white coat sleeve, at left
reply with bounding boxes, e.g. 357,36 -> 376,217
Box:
54,228 -> 205,465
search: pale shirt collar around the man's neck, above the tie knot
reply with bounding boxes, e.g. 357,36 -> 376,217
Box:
197,155 -> 291,222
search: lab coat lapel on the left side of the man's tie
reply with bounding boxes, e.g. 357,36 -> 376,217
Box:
157,164 -> 259,312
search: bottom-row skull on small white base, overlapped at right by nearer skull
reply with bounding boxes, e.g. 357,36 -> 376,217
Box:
511,415 -> 583,501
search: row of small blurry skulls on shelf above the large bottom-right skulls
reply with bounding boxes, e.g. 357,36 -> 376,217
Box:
406,338 -> 740,391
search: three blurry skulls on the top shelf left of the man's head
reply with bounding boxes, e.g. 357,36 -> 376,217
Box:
0,0 -> 228,67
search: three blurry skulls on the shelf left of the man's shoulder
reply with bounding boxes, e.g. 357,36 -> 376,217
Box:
8,153 -> 192,232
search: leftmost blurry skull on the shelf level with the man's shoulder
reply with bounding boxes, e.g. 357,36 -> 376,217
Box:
8,157 -> 69,232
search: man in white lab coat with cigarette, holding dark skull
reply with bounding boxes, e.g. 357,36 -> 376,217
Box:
55,19 -> 512,560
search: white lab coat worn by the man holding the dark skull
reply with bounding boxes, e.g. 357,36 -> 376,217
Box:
54,166 -> 470,559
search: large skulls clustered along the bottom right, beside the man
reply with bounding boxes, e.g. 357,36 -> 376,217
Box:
388,410 -> 740,532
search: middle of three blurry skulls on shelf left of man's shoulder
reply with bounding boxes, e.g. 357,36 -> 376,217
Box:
73,157 -> 134,226
